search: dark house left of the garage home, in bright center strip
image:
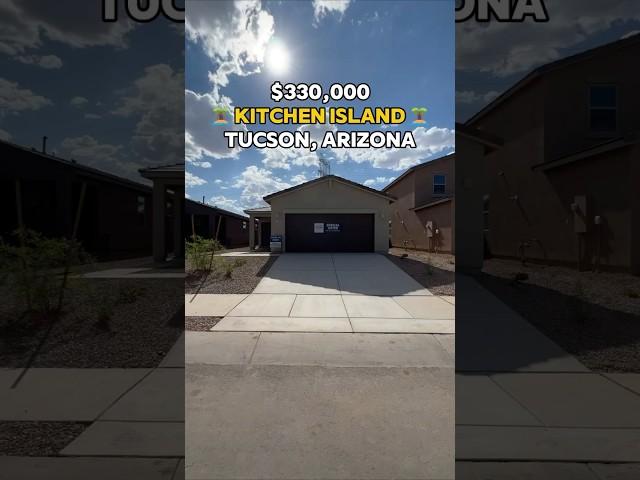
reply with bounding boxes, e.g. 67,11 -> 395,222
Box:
184,199 -> 250,248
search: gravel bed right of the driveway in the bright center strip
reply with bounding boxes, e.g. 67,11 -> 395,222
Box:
387,248 -> 456,296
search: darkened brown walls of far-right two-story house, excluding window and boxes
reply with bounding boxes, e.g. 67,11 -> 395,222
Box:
470,46 -> 640,269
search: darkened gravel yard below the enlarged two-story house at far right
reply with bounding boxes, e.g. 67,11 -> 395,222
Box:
477,259 -> 640,373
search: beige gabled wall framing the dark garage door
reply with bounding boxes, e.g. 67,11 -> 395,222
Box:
271,179 -> 389,252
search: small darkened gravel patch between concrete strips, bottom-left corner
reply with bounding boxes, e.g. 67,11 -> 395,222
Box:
0,422 -> 88,457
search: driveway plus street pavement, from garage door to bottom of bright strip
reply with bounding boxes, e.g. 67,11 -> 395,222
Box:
185,254 -> 455,480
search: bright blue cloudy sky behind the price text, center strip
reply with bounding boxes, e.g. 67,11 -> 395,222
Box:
185,0 -> 455,211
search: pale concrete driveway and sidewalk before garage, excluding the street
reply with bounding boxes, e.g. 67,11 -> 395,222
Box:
187,254 -> 455,334
